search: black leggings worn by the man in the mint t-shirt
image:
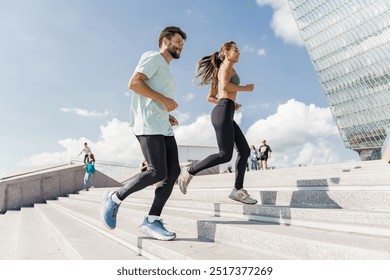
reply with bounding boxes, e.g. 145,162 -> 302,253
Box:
117,135 -> 180,216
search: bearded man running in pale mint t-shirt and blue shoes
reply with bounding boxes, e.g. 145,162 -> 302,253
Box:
102,26 -> 187,240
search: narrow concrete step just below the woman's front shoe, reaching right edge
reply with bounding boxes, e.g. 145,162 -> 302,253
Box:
66,190 -> 390,237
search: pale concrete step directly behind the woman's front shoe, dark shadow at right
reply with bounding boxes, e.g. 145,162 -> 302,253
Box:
80,182 -> 390,211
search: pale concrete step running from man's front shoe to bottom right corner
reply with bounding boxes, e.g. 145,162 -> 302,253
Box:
53,192 -> 390,259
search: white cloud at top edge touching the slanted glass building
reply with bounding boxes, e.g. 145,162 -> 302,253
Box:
257,0 -> 304,46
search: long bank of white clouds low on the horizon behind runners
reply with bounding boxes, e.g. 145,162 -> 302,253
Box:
22,99 -> 358,171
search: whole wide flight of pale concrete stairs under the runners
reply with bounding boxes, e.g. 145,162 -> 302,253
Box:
0,161 -> 390,260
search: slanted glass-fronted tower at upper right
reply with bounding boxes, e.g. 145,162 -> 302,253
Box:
288,0 -> 390,160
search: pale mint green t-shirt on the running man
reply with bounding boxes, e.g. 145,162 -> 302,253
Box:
129,51 -> 176,136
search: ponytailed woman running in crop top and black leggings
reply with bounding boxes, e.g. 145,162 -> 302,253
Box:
179,41 -> 257,204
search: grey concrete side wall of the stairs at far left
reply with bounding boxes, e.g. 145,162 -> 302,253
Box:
0,165 -> 121,213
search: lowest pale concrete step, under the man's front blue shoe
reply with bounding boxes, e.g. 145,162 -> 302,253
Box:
49,200 -> 284,260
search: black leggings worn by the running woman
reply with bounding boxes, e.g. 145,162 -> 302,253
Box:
188,98 -> 250,190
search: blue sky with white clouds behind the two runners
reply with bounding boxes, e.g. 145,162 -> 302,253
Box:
0,0 -> 358,173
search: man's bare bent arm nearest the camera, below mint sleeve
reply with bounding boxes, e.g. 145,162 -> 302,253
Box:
129,72 -> 178,112
